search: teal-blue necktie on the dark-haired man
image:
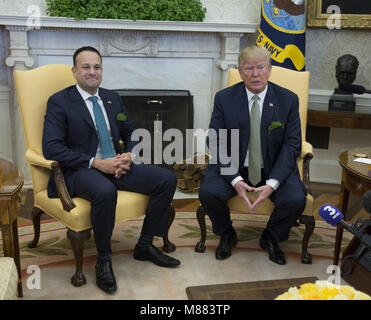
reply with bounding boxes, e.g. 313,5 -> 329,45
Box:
88,96 -> 115,159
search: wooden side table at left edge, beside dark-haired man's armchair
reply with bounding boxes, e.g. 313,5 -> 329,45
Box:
0,159 -> 23,297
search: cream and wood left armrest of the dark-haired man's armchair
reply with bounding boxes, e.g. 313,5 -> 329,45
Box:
26,150 -> 76,212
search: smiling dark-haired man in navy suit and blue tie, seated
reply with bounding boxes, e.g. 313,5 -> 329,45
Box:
42,47 -> 180,293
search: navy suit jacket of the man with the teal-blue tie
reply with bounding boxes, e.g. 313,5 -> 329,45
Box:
42,86 -> 138,197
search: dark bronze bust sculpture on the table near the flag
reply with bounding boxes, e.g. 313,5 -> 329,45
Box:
329,54 -> 359,111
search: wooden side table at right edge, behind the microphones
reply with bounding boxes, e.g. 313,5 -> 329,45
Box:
333,147 -> 371,265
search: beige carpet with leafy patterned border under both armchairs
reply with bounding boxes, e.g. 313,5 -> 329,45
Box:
5,188 -> 366,300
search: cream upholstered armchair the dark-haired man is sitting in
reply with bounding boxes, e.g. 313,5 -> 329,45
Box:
14,64 -> 175,287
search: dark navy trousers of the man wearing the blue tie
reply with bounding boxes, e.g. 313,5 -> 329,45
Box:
73,164 -> 176,255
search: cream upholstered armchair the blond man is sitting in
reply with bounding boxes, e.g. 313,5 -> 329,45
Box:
195,66 -> 315,264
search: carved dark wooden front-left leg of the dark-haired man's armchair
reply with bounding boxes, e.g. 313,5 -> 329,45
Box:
67,228 -> 91,287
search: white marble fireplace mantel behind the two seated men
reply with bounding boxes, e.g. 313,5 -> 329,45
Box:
0,15 -> 258,186
